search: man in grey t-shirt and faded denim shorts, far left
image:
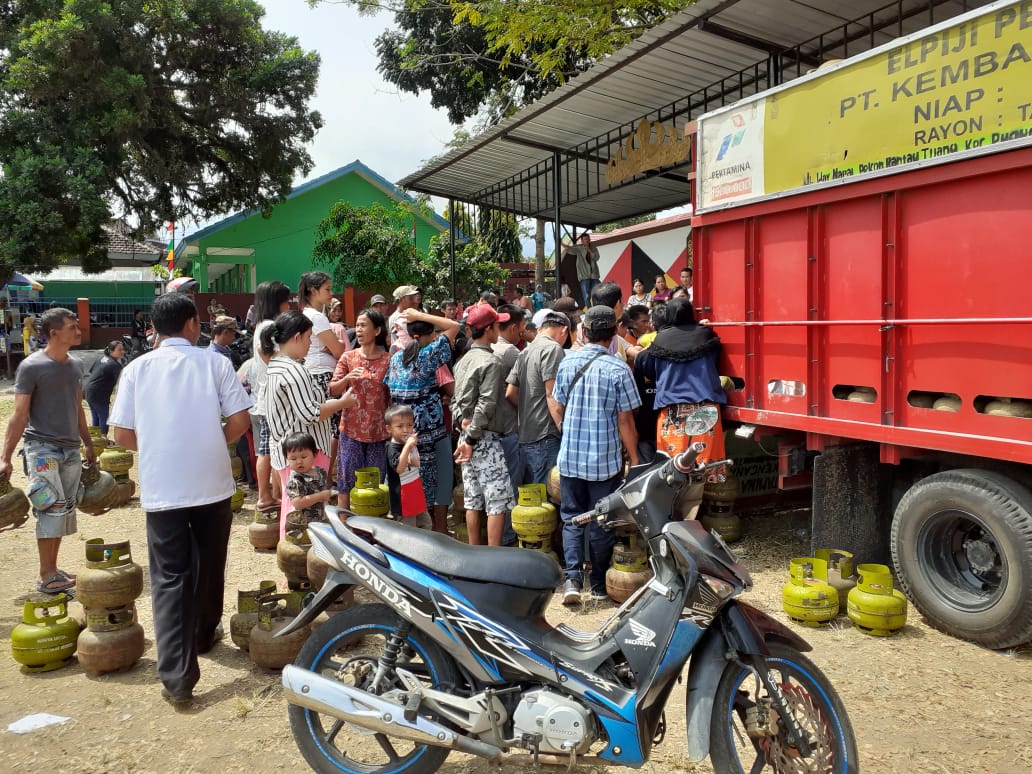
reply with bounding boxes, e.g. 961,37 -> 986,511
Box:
0,308 -> 96,593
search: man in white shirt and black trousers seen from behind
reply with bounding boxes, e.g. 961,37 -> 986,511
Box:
109,293 -> 251,706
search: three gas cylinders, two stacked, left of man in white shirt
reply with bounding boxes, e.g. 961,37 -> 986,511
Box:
10,538 -> 144,674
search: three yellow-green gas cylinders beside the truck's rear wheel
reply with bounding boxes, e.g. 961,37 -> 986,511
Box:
781,549 -> 907,637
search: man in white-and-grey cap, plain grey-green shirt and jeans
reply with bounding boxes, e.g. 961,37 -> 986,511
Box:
506,310 -> 570,484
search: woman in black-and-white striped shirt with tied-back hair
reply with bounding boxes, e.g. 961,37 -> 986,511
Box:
261,312 -> 357,535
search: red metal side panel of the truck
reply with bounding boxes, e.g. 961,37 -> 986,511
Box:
694,149 -> 1032,462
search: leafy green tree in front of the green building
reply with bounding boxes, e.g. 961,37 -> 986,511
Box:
312,201 -> 420,288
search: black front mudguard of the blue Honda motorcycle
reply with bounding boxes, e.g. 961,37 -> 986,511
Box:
684,602 -> 812,763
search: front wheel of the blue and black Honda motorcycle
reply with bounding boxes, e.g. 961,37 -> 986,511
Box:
710,642 -> 860,774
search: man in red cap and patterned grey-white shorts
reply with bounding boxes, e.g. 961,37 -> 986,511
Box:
452,303 -> 516,546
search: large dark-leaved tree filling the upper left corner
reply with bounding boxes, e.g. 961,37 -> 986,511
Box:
0,0 -> 322,280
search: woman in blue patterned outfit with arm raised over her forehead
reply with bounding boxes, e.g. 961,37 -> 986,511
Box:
384,309 -> 460,533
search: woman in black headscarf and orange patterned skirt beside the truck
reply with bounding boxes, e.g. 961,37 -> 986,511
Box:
635,297 -> 728,519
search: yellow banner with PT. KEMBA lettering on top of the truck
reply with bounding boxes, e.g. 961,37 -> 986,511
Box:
764,1 -> 1032,194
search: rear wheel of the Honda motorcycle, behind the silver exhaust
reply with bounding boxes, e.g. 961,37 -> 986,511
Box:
288,605 -> 459,774
